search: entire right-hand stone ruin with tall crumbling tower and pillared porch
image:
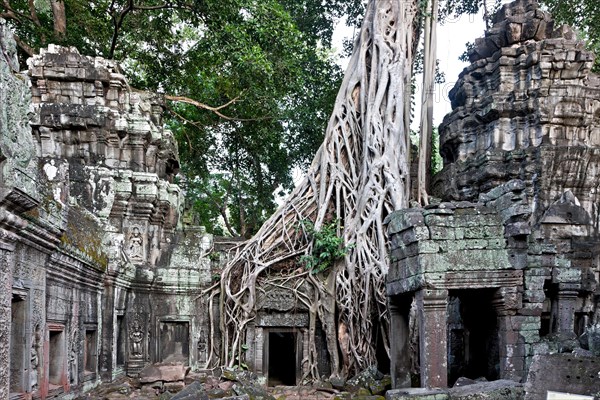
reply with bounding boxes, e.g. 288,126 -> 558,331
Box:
387,1 -> 600,398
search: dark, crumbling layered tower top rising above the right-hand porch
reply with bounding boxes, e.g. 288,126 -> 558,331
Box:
435,0 -> 600,229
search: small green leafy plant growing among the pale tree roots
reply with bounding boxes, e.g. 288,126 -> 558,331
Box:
300,220 -> 352,274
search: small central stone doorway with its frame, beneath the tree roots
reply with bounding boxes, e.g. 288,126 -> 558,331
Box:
264,329 -> 302,386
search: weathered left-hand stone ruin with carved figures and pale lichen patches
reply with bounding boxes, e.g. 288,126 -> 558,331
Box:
0,21 -> 220,398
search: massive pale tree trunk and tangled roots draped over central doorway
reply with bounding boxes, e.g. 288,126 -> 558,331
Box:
214,0 -> 417,379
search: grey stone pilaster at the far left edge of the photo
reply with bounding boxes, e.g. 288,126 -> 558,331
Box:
0,230 -> 15,399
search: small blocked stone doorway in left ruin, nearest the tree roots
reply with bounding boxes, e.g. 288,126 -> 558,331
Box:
159,321 -> 190,365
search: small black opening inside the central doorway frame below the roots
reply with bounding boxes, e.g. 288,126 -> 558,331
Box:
269,332 -> 296,386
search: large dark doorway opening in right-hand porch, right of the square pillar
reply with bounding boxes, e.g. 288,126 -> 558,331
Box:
448,289 -> 500,386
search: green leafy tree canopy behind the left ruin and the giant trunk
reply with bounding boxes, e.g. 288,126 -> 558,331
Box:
0,0 -> 362,236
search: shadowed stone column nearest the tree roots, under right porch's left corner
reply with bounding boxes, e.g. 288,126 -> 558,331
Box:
388,296 -> 411,389
